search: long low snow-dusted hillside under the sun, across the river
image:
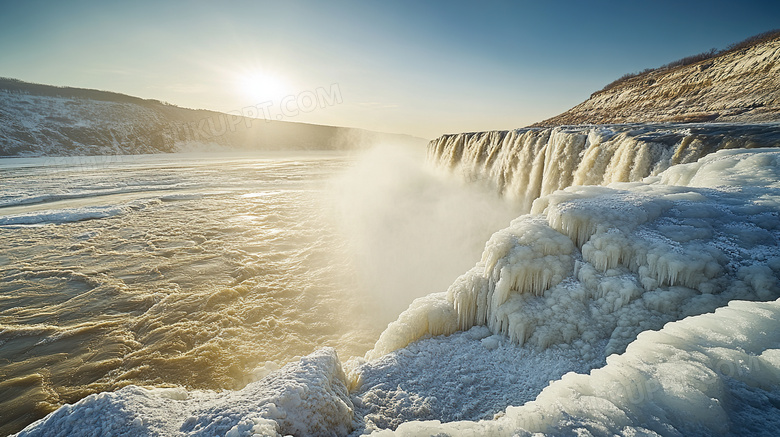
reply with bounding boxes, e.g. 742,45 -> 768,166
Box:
0,79 -> 425,157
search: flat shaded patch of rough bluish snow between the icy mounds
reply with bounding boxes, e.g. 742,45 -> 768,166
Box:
348,326 -> 601,433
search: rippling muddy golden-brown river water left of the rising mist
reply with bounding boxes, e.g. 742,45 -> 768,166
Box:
0,154 -> 382,434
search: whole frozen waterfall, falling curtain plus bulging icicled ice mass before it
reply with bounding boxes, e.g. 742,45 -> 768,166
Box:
368,125 -> 780,358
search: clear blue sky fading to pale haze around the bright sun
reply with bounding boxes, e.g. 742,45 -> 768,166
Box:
0,0 -> 780,138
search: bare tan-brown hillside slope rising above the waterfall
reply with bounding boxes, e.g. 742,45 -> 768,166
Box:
532,32 -> 780,127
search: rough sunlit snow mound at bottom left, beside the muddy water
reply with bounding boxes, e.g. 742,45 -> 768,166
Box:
16,348 -> 354,437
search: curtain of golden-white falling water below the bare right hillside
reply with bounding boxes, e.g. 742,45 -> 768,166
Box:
428,123 -> 780,211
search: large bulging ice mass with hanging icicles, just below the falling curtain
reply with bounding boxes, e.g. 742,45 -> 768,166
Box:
368,149 -> 780,358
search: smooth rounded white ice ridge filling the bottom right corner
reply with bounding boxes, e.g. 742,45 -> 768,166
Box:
386,301 -> 780,436
